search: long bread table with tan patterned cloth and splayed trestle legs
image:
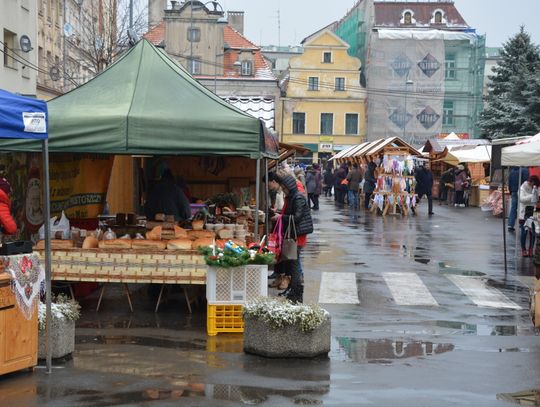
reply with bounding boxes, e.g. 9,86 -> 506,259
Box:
36,248 -> 207,313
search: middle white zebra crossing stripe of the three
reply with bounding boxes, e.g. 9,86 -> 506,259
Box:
383,273 -> 439,306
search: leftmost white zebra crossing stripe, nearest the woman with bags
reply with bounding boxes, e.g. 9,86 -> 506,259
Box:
319,272 -> 360,304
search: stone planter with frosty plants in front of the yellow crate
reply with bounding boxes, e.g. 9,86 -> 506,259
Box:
243,298 -> 331,358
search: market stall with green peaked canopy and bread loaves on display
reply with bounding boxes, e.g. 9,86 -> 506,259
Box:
0,40 -> 278,320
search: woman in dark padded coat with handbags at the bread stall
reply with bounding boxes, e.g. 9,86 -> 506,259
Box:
275,175 -> 313,302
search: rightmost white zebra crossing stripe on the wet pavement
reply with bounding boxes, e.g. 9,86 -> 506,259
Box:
446,275 -> 522,310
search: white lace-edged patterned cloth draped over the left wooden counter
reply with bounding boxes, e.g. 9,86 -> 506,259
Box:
0,253 -> 45,319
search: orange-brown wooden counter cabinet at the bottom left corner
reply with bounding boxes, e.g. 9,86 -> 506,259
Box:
0,272 -> 38,375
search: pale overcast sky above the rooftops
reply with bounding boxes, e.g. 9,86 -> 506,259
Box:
219,0 -> 540,47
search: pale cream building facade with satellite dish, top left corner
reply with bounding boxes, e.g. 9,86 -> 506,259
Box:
0,0 -> 38,97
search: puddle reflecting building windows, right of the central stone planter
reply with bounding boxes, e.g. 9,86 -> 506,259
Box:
336,337 -> 454,364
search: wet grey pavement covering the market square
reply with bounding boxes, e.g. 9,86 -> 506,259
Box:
0,198 -> 540,407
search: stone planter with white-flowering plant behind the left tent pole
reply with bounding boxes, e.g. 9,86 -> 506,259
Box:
38,294 -> 81,359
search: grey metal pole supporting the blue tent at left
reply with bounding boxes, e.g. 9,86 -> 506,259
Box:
43,139 -> 52,373
